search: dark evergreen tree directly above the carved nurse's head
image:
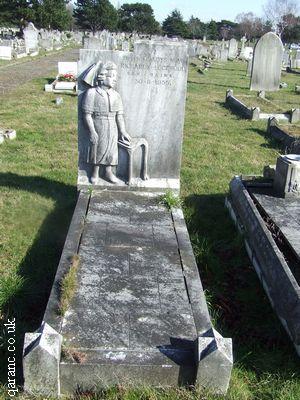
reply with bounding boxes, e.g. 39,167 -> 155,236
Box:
74,0 -> 118,33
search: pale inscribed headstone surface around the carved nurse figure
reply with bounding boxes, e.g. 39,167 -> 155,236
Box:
78,41 -> 188,188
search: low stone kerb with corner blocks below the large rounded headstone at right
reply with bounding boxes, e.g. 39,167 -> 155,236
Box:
225,89 -> 300,123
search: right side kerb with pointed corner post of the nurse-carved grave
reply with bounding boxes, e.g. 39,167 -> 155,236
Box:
172,208 -> 233,394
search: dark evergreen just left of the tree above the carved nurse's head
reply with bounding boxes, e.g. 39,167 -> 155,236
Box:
36,0 -> 71,30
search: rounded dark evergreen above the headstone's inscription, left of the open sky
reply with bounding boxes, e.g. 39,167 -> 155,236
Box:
119,3 -> 160,34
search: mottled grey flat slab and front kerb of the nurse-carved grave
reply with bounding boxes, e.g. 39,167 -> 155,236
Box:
56,191 -> 231,394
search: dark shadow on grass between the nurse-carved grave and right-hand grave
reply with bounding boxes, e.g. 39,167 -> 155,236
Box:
184,194 -> 300,376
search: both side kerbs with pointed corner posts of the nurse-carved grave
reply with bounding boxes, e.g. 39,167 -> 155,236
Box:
23,190 -> 233,396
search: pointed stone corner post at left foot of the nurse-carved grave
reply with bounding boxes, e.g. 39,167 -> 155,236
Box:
23,322 -> 62,396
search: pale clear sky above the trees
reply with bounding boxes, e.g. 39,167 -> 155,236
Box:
111,0 -> 267,22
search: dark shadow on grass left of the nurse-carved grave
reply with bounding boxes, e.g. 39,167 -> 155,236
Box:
0,173 -> 76,384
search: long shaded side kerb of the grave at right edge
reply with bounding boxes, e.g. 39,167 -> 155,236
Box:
225,176 -> 300,356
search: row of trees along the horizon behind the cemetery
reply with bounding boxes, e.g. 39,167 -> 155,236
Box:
0,0 -> 300,42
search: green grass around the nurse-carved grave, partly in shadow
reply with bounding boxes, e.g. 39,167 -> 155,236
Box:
0,62 -> 300,400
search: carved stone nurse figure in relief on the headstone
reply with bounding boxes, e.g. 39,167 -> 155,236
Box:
82,62 -> 130,184
